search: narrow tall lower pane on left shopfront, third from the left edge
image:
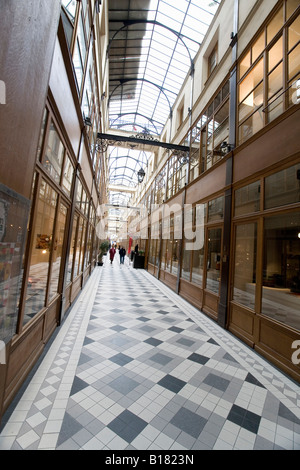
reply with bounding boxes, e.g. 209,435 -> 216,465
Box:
48,204 -> 67,301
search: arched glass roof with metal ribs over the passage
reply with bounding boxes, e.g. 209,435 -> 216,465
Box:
108,0 -> 220,235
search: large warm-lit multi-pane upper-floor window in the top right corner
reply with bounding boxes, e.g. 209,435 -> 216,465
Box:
238,0 -> 300,143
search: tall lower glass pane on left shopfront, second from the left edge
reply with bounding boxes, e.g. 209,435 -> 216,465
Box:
24,181 -> 57,324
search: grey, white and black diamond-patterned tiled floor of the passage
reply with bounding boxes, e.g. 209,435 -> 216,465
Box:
0,253 -> 300,451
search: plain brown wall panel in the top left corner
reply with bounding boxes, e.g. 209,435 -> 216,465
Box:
0,0 -> 60,198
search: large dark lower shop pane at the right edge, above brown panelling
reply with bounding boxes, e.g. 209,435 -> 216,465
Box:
261,212 -> 300,330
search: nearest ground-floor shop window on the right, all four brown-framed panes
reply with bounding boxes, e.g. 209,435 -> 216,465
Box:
232,163 -> 300,330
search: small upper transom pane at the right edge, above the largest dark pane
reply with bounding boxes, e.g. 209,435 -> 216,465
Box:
265,164 -> 300,209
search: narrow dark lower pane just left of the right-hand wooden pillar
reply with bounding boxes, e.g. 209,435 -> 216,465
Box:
206,228 -> 222,294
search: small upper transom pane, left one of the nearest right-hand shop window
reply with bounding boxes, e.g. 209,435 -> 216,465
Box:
234,181 -> 260,216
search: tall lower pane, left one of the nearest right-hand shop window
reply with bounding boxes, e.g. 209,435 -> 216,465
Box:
233,223 -> 257,310
